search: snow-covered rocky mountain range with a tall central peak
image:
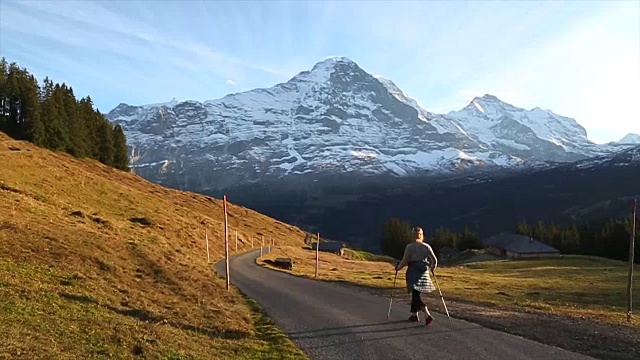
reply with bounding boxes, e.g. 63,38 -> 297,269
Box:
107,57 -> 632,191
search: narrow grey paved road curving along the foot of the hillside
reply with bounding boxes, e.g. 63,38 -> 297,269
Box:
215,251 -> 592,360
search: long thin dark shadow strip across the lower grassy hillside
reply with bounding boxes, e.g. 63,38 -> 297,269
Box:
59,292 -> 251,340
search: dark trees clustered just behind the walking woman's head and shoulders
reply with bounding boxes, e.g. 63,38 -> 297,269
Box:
380,218 -> 482,259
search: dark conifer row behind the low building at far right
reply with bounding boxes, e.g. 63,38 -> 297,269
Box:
516,217 -> 640,263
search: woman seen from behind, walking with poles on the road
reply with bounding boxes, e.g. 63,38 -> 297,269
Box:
396,227 -> 438,326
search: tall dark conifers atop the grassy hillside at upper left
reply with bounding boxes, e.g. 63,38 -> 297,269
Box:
0,57 -> 129,171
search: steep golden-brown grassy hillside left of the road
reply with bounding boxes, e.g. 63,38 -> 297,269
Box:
0,133 -> 304,359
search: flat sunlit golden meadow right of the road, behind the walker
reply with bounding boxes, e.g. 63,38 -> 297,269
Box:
258,246 -> 640,327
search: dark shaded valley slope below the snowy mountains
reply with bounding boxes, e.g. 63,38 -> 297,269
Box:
212,146 -> 640,251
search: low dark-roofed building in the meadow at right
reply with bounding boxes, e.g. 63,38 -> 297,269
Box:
482,232 -> 560,258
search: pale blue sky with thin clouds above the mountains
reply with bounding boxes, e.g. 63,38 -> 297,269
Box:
0,0 -> 640,143
